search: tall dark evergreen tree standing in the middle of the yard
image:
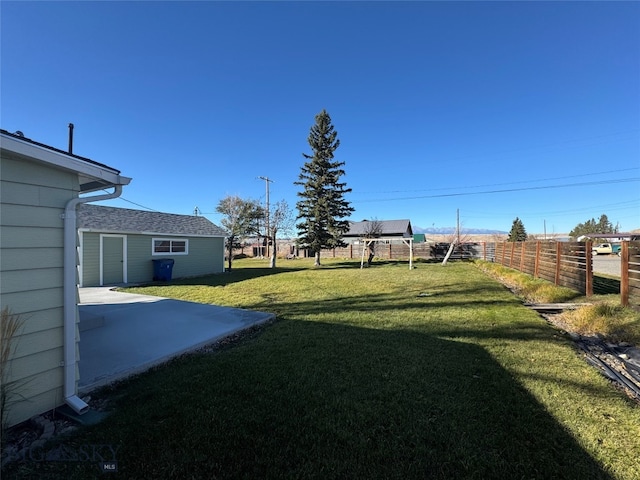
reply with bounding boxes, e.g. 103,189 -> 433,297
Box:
294,110 -> 354,266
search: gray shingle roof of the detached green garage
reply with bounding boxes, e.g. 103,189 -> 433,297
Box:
77,203 -> 227,237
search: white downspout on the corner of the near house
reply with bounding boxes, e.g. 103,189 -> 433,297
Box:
63,185 -> 122,414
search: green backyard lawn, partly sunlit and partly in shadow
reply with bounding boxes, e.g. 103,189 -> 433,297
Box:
3,259 -> 640,480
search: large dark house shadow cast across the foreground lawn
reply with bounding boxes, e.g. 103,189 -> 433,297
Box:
6,320 -> 612,480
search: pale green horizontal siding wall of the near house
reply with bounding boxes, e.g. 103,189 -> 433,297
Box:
0,151 -> 79,425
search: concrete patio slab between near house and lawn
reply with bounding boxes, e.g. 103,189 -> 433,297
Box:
78,287 -> 275,393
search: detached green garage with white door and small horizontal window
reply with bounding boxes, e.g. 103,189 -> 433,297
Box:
78,204 -> 226,287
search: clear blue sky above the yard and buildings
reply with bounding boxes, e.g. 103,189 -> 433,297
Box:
0,1 -> 640,233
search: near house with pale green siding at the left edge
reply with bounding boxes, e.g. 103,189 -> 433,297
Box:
0,130 -> 131,426
